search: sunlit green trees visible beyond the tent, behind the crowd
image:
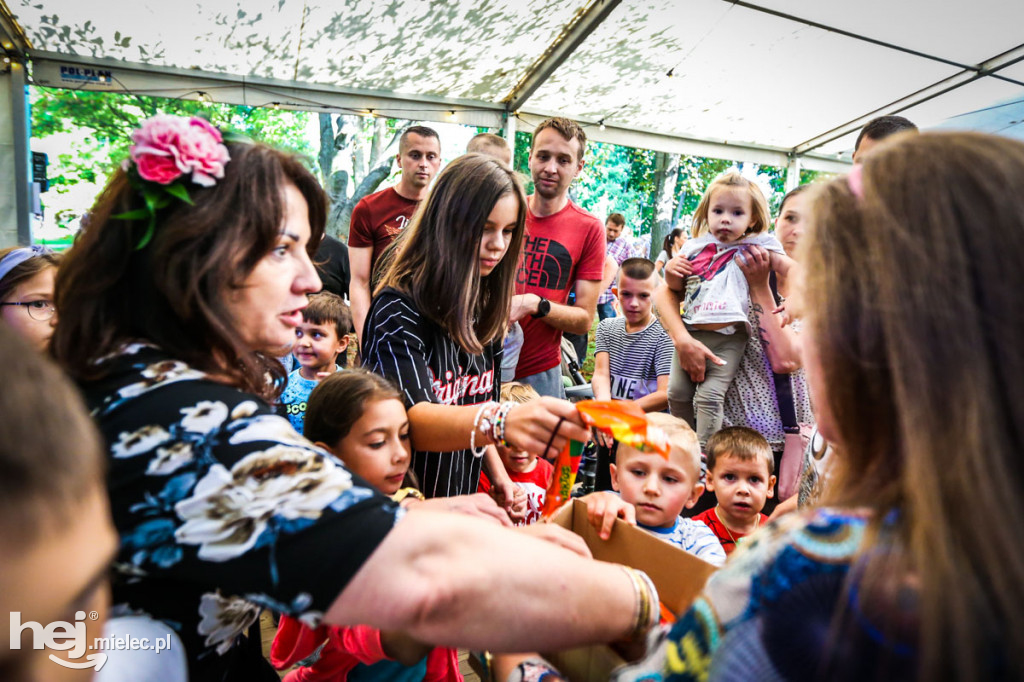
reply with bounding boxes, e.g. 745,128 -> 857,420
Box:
32,87 -> 830,238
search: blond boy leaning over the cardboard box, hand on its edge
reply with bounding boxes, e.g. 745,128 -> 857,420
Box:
584,413 -> 725,566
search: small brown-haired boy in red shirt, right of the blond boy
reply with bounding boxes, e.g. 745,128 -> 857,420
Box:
693,426 -> 775,554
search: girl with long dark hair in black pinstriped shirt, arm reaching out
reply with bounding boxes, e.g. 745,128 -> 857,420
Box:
362,154 -> 587,499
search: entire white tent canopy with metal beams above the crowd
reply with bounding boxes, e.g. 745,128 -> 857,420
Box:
0,0 -> 1024,241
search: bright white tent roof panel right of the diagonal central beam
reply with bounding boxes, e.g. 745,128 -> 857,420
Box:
530,0 -> 957,148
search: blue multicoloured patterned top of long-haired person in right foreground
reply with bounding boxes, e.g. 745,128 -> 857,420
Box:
613,509 -> 880,682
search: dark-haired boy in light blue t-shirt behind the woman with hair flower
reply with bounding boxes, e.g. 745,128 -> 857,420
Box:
280,293 -> 352,433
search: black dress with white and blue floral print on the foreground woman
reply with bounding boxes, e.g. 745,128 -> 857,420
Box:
82,344 -> 401,681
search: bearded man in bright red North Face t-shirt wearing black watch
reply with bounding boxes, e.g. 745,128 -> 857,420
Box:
511,118 -> 605,397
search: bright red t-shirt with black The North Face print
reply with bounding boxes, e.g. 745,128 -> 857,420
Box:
515,201 -> 605,379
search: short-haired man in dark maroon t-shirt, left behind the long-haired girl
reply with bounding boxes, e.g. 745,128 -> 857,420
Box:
348,126 -> 441,342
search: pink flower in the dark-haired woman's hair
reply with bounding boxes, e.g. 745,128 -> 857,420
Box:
131,114 -> 230,187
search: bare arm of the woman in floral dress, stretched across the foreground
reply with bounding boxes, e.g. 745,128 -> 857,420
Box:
327,510 -> 637,651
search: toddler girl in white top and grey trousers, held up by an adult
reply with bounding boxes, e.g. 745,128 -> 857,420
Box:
660,171 -> 792,445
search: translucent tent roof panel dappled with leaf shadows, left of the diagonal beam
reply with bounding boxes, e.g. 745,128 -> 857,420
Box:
16,0 -> 583,101
